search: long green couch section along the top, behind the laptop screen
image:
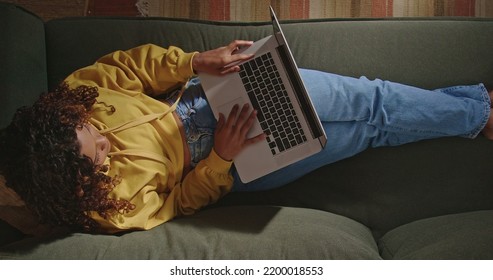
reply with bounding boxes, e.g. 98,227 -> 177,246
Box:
46,18 -> 493,88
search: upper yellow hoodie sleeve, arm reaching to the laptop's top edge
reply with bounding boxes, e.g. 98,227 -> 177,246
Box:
66,44 -> 197,96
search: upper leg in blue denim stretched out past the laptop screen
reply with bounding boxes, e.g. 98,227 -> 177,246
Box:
302,70 -> 490,141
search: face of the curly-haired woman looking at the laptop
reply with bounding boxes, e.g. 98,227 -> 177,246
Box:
75,124 -> 111,165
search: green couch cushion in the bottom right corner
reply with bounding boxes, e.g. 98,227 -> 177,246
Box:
379,210 -> 493,259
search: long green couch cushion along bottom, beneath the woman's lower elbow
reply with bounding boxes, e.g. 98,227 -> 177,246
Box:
0,206 -> 380,259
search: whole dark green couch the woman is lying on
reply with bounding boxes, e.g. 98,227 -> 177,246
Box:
0,4 -> 493,259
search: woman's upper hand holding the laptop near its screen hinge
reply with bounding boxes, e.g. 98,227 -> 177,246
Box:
192,40 -> 253,75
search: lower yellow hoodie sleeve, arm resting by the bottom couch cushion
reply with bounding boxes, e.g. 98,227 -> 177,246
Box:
92,150 -> 233,233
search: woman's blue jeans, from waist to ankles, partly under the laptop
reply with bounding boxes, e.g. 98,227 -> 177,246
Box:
171,70 -> 490,191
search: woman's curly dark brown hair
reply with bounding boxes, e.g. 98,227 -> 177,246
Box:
0,83 -> 134,231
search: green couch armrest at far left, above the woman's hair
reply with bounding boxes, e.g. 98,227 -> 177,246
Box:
0,3 -> 47,128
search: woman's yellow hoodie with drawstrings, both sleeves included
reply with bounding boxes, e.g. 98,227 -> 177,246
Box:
65,44 -> 233,232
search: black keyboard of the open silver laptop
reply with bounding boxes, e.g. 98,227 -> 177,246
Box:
239,53 -> 307,155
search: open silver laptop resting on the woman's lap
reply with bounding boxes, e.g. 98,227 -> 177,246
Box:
199,7 -> 327,183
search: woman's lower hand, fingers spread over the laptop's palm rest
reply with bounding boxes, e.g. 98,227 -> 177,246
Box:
214,104 -> 265,161
